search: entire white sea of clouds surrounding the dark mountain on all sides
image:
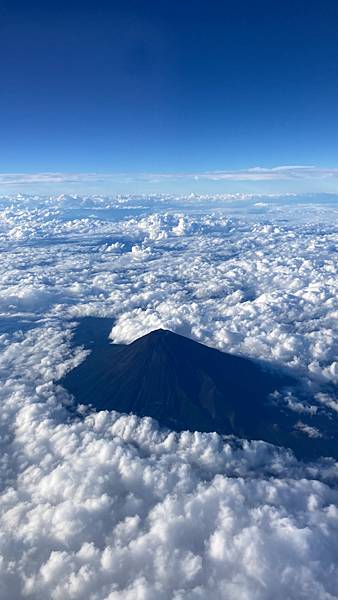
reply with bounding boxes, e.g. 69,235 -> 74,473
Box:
0,195 -> 338,600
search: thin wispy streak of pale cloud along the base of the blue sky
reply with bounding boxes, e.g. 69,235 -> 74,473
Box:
0,165 -> 338,185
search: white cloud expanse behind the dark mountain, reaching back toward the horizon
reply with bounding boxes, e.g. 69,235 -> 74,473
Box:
0,197 -> 338,384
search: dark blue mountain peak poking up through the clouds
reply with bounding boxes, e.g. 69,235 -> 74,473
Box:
61,319 -> 336,457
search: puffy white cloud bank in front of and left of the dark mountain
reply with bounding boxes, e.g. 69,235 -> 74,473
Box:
0,324 -> 338,600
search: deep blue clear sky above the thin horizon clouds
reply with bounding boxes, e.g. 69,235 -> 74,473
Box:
0,0 -> 338,192
